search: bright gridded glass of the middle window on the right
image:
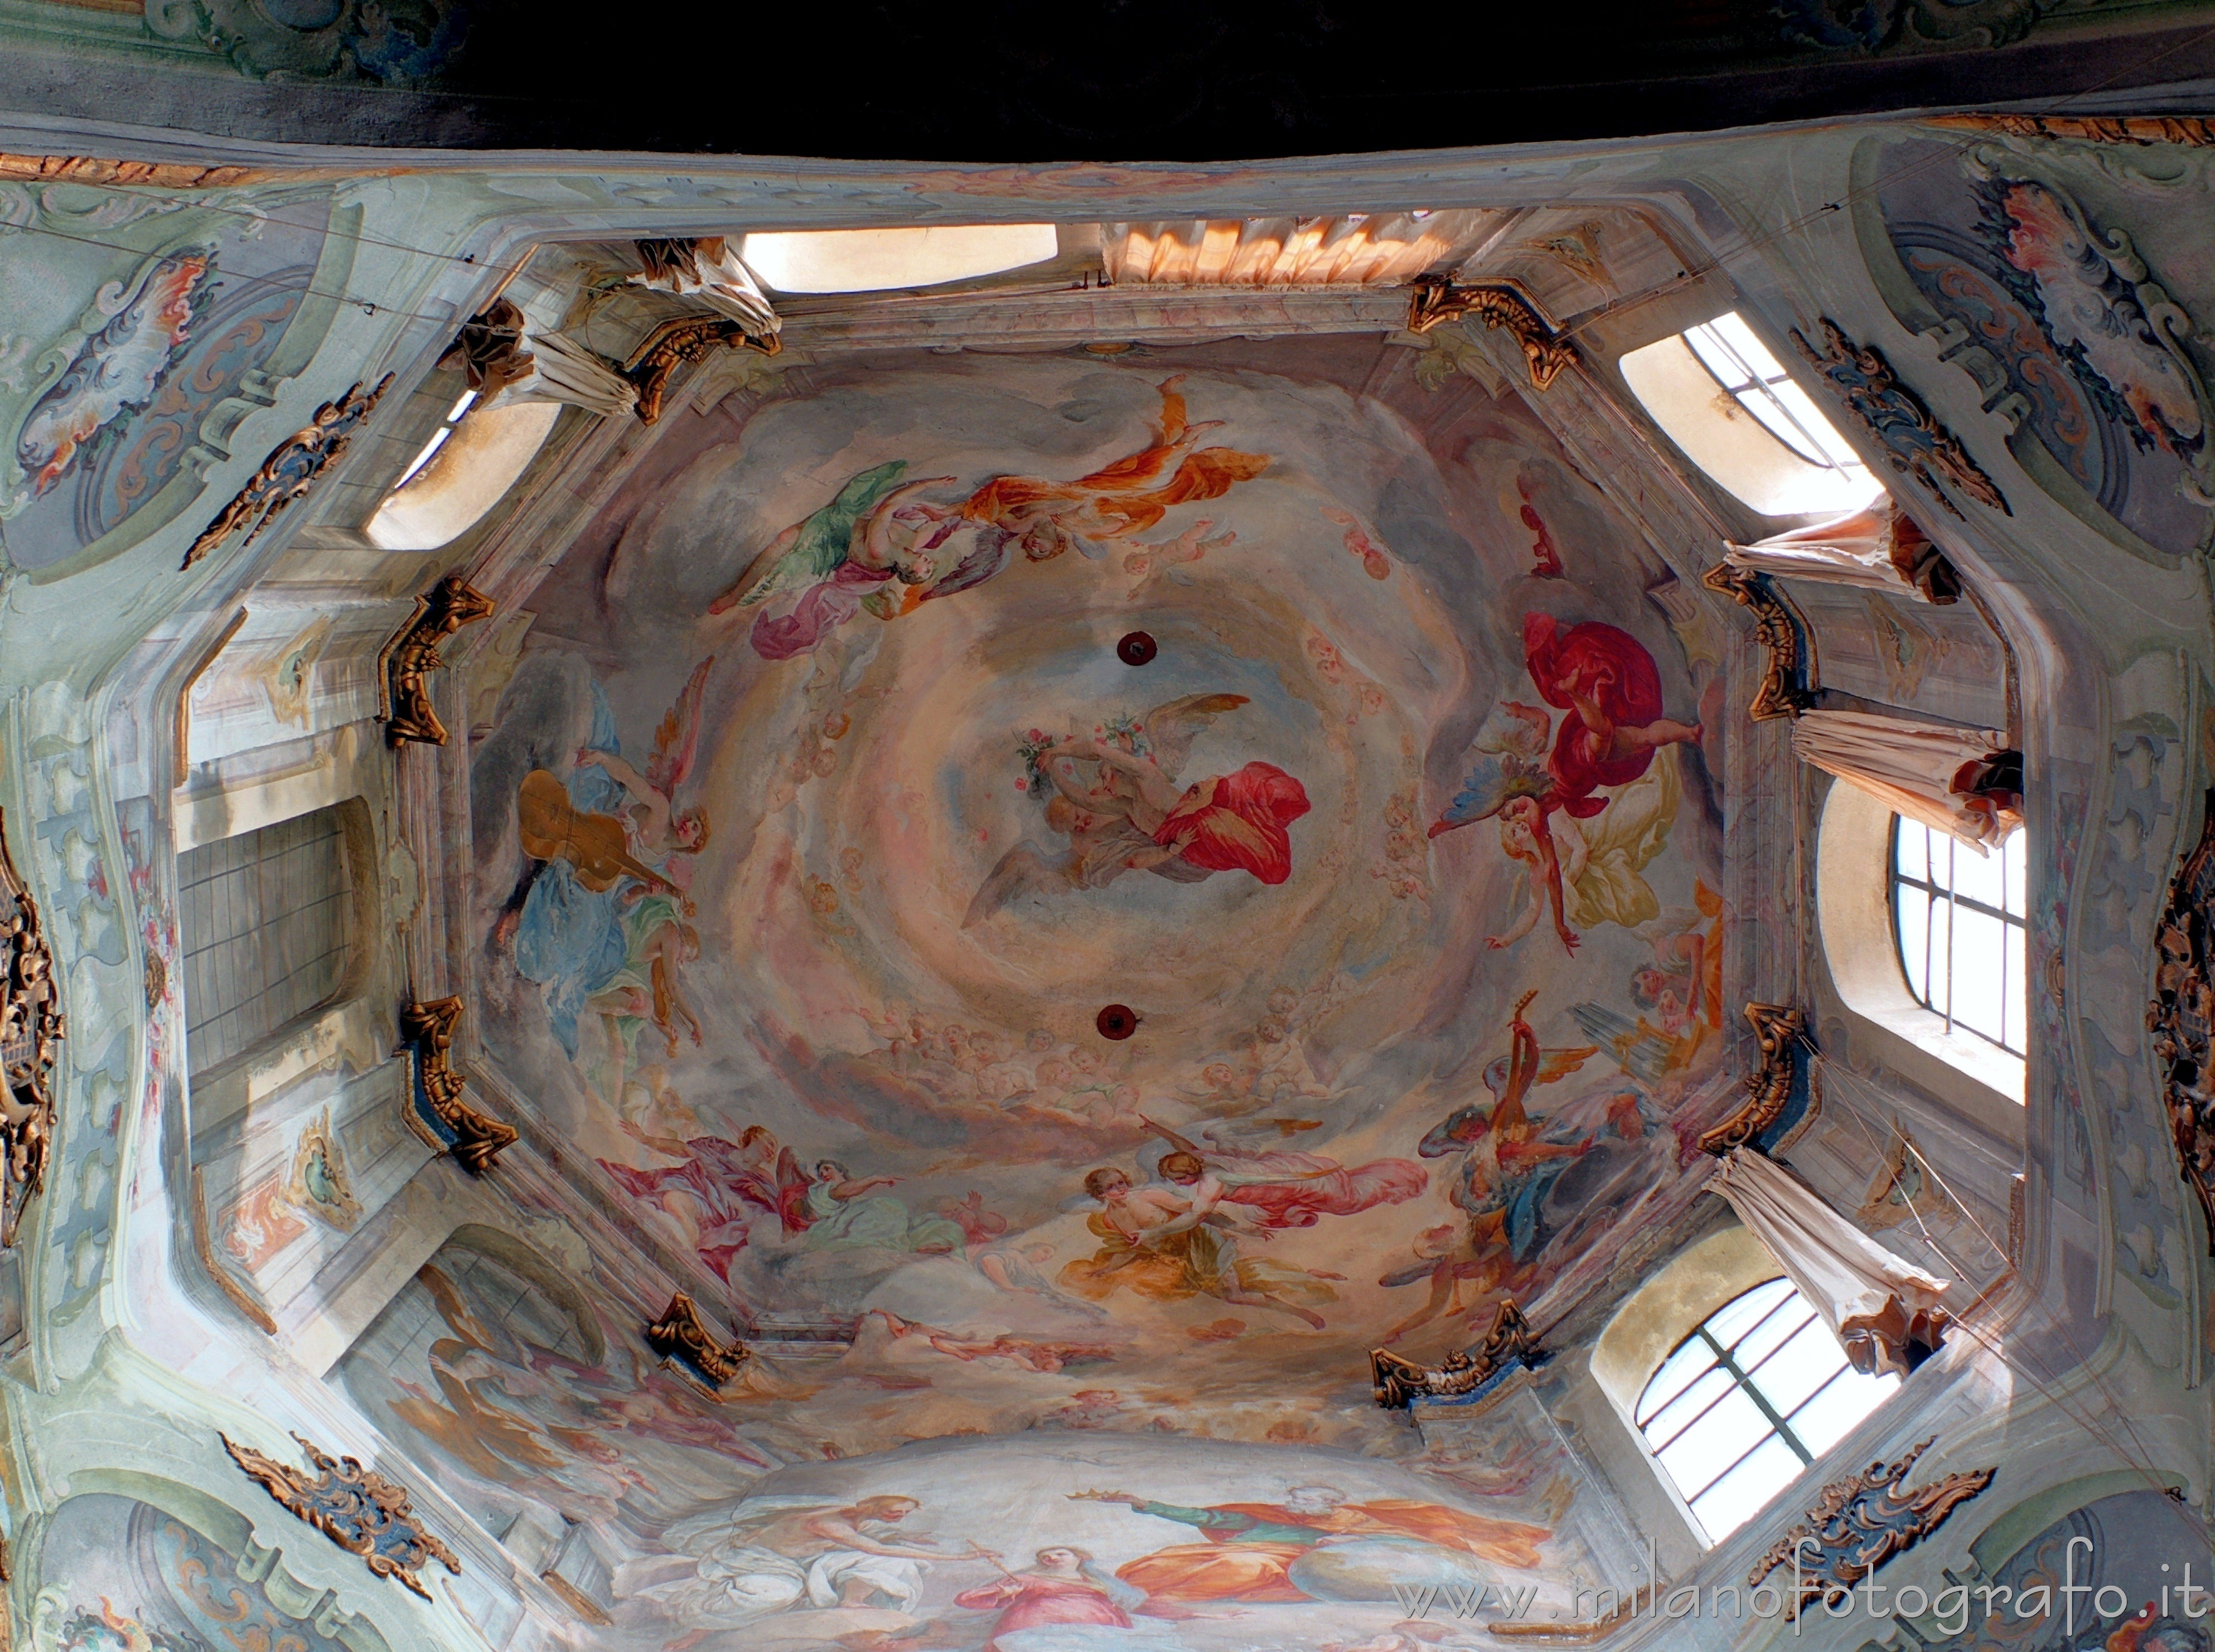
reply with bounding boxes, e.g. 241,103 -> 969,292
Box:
1889,815 -> 2029,1057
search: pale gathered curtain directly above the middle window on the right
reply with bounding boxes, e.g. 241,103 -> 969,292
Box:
1792,711 -> 2022,855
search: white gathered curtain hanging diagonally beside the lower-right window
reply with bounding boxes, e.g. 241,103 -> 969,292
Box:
1708,1147 -> 1951,1375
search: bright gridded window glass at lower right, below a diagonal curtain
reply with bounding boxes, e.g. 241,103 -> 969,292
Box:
1634,1280 -> 1900,1543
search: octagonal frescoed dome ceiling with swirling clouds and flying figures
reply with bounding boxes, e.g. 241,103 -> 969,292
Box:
472,335 -> 1723,1453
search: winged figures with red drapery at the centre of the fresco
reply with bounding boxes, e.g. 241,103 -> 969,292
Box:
961,693 -> 1309,928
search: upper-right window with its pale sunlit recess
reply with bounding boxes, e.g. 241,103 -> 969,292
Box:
1617,312 -> 1883,516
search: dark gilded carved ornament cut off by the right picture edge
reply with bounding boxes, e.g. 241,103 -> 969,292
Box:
2146,791 -> 2215,1256
